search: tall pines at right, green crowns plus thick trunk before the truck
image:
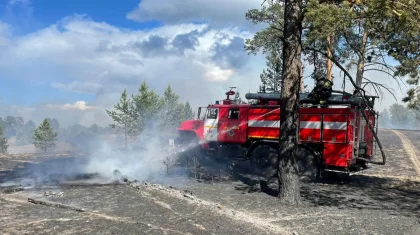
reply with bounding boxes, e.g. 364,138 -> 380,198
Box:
245,0 -> 420,203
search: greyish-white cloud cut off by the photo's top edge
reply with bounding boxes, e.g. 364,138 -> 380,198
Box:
127,0 -> 262,27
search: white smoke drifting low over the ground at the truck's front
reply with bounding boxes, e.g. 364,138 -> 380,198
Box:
84,108 -> 195,184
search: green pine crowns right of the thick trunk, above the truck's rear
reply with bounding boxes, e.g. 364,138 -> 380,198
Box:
304,0 -> 420,95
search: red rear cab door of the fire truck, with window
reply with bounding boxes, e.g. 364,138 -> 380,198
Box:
219,107 -> 247,144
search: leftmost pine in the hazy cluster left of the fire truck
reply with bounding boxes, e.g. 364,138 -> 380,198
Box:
105,89 -> 139,148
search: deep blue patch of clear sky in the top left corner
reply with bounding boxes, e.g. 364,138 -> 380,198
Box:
0,0 -> 162,34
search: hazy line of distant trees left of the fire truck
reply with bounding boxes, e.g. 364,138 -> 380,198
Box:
0,82 -> 195,152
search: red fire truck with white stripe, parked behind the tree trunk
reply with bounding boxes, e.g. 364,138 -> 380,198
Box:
176,89 -> 385,177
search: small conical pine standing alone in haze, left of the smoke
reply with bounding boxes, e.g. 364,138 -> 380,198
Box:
33,118 -> 57,152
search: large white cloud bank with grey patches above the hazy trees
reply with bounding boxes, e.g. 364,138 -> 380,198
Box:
0,16 -> 265,125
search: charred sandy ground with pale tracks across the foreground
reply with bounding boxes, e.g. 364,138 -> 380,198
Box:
0,130 -> 420,235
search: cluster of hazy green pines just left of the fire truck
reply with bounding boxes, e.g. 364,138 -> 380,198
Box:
107,82 -> 194,145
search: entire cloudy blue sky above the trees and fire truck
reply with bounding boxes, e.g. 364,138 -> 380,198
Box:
0,0 -> 406,126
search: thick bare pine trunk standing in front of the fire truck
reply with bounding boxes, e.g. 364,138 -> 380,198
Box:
278,0 -> 302,204
